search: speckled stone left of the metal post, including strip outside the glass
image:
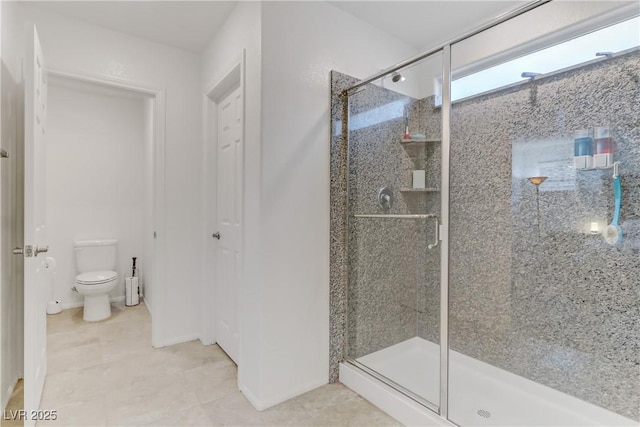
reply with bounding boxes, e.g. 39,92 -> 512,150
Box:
331,72 -> 440,380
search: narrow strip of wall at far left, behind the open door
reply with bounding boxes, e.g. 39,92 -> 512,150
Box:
0,2 -> 24,408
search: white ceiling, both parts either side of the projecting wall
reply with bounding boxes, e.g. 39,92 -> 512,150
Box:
29,0 -> 527,53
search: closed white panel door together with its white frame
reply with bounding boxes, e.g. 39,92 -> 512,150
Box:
202,55 -> 244,364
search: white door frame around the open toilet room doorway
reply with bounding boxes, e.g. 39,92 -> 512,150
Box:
47,68 -> 167,347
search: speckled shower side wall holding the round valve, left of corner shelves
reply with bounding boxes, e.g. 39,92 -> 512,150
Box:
347,81 -> 422,358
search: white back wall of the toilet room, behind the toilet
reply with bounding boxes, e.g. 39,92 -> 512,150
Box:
46,78 -> 149,308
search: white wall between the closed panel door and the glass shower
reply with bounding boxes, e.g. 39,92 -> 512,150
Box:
202,2 -> 416,409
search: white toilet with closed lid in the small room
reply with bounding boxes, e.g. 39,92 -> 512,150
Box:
73,239 -> 118,322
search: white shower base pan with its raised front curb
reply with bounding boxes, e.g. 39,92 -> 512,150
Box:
340,337 -> 638,426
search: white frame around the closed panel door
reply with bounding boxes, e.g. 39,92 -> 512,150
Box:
200,49 -> 246,352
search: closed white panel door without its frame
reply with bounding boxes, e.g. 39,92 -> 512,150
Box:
216,88 -> 243,363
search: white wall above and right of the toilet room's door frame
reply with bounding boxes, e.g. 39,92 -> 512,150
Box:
15,3 -> 202,345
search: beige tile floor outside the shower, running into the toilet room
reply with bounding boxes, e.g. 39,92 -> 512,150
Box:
21,305 -> 400,426
